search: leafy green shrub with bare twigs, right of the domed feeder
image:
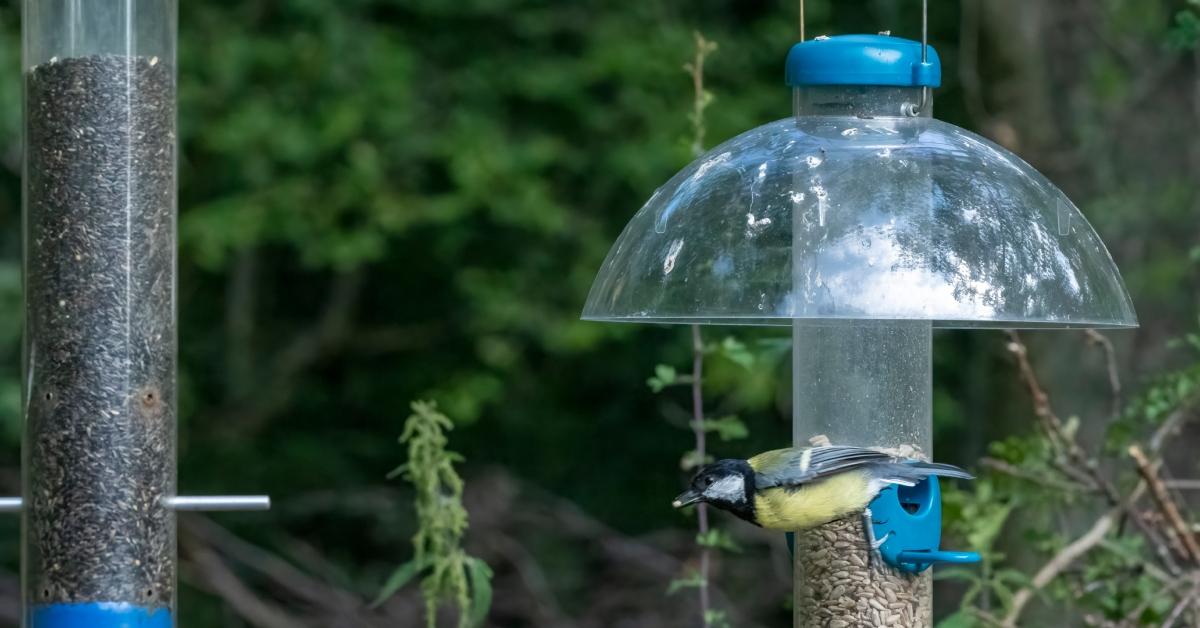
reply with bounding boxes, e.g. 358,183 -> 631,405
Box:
938,333 -> 1200,628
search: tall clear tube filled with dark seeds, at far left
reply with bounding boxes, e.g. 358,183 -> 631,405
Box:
23,0 -> 176,628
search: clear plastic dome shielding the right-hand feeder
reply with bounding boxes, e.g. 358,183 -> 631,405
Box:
583,92 -> 1136,328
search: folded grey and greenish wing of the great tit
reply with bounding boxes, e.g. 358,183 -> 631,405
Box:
749,447 -> 895,489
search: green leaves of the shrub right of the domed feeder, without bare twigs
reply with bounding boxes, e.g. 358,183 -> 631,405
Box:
937,326 -> 1200,628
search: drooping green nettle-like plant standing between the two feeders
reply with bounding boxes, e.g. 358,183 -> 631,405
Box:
376,401 -> 492,628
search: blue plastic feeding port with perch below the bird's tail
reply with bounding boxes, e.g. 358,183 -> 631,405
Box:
870,477 -> 980,574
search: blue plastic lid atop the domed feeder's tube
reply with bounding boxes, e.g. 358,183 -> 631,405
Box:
786,35 -> 942,88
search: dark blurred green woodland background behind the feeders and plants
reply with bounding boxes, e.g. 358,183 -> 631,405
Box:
0,0 -> 1200,628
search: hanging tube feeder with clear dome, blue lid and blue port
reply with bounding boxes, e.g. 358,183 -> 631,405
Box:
583,35 -> 1136,627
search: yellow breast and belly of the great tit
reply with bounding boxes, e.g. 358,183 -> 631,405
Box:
754,471 -> 872,531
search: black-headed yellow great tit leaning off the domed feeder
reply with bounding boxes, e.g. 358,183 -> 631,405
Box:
672,447 -> 973,532
